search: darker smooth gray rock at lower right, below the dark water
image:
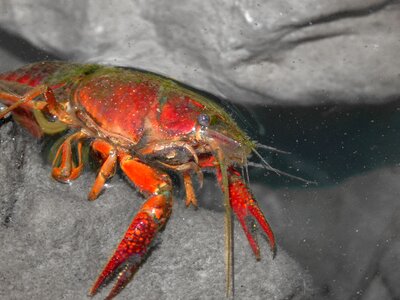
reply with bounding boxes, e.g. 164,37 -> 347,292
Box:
253,166 -> 400,299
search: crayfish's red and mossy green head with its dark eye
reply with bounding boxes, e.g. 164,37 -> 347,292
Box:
155,85 -> 255,169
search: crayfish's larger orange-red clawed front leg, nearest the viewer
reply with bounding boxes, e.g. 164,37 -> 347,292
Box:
89,153 -> 172,299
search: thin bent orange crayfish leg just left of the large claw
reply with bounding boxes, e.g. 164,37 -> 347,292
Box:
88,140 -> 117,201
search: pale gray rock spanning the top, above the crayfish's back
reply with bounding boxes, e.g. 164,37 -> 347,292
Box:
0,0 -> 400,104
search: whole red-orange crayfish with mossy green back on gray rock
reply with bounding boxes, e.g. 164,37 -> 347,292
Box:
0,62 -> 276,299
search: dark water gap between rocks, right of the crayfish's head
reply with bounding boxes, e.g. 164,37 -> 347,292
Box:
244,102 -> 400,186
